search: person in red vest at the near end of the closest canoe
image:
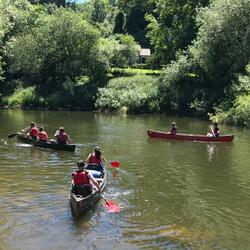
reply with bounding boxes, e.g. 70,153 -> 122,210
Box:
72,161 -> 100,197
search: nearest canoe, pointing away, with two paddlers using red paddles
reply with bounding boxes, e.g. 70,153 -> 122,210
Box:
69,164 -> 106,216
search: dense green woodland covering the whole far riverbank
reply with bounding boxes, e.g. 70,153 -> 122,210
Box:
0,0 -> 250,126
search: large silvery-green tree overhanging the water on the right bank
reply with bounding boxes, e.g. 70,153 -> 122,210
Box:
159,0 -> 250,114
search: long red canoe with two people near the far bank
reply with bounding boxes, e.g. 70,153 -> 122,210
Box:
148,130 -> 234,142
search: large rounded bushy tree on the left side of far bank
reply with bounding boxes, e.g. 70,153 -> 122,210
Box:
7,9 -> 105,96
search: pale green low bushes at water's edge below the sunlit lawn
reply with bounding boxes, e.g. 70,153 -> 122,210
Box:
96,76 -> 159,112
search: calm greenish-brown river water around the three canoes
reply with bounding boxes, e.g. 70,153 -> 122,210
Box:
0,110 -> 250,250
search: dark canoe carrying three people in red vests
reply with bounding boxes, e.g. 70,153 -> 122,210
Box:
17,132 -> 76,151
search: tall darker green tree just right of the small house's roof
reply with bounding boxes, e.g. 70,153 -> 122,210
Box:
146,0 -> 209,65
